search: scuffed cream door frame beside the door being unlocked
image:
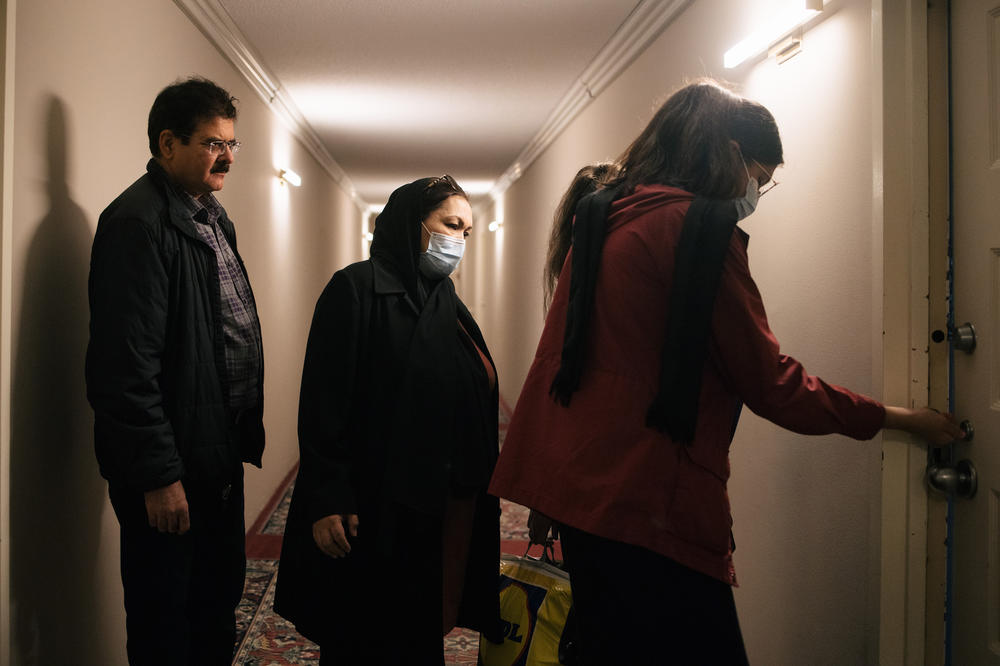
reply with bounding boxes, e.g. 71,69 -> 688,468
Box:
872,0 -> 948,665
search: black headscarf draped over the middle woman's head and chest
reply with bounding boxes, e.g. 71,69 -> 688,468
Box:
371,178 -> 496,514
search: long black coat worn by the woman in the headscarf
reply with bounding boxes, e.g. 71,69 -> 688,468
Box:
275,257 -> 500,649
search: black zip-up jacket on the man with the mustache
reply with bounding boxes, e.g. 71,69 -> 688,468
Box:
86,160 -> 264,491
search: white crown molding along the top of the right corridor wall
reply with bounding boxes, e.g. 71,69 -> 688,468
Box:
490,0 -> 693,198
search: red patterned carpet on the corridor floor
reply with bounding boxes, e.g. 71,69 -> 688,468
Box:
233,402 -> 540,666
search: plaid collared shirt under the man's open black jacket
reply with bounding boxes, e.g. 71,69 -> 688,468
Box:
179,192 -> 261,413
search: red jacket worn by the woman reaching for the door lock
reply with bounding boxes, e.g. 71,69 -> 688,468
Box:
490,186 -> 885,584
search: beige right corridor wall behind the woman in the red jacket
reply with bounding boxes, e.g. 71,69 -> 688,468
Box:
463,0 -> 882,664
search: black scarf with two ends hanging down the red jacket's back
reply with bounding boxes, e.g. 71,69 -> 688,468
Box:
550,189 -> 737,443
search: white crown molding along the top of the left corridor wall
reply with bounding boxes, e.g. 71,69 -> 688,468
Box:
174,0 -> 368,211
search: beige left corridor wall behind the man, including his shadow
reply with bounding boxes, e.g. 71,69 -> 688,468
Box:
4,0 -> 361,666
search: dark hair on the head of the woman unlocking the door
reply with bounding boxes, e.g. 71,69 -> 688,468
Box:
619,79 -> 784,199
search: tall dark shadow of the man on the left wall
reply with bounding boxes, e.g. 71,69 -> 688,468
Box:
11,97 -> 105,665
